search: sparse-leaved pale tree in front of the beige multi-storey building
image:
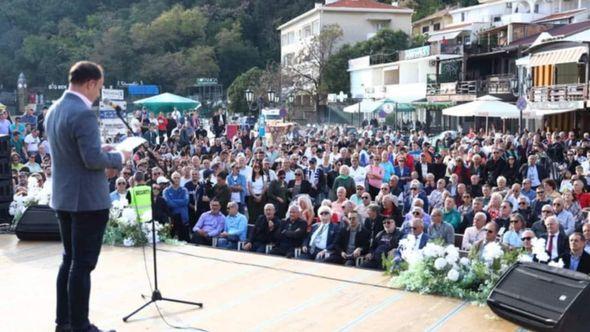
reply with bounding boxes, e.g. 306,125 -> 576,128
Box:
283,24 -> 342,122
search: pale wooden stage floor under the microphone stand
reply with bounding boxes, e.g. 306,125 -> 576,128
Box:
0,235 -> 520,332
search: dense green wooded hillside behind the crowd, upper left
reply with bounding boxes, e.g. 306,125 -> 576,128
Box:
0,0 -> 313,93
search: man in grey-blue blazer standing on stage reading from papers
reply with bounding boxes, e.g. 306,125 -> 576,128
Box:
45,61 -> 131,331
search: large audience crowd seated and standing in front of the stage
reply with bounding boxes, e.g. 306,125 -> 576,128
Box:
6,106 -> 590,273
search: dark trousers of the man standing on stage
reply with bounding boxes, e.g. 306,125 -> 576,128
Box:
55,210 -> 109,331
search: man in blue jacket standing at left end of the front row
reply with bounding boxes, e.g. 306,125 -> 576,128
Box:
164,172 -> 190,242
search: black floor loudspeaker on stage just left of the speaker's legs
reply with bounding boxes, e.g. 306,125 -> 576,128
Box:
15,205 -> 61,241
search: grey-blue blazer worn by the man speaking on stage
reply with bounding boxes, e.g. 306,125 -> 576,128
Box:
45,92 -> 122,212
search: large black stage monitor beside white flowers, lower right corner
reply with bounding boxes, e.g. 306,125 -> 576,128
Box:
487,263 -> 590,332
